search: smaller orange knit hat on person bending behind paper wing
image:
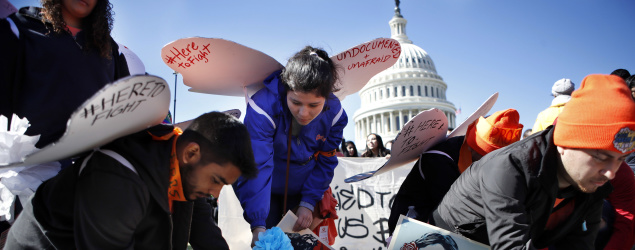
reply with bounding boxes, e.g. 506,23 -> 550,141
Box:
466,109 -> 523,155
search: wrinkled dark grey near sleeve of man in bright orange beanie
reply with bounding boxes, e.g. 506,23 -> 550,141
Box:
480,161 -> 531,249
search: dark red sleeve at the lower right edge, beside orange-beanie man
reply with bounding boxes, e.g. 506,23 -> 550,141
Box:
604,162 -> 635,249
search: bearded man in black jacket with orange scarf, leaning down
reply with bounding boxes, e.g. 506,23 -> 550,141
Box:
6,112 -> 257,249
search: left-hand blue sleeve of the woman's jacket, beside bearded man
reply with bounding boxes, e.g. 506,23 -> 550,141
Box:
234,100 -> 275,228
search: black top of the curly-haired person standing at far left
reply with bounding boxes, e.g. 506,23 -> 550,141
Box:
0,1 -> 129,148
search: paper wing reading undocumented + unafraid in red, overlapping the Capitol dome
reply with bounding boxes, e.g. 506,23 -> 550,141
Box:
331,38 -> 401,100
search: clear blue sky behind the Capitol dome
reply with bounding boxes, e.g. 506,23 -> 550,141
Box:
9,0 -> 635,148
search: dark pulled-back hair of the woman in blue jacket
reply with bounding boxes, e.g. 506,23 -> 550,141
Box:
281,46 -> 339,97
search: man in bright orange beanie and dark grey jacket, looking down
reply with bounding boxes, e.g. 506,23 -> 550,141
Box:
432,75 -> 635,249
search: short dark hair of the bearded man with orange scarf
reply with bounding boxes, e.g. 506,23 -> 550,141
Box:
177,112 -> 258,178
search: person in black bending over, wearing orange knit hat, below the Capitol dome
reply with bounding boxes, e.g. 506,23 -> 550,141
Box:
388,109 -> 523,234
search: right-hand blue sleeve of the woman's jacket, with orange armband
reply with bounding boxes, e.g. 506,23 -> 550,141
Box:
300,108 -> 348,210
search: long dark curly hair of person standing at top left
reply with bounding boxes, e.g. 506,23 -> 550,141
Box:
41,0 -> 114,59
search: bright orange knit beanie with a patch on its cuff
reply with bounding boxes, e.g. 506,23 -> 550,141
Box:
553,75 -> 635,153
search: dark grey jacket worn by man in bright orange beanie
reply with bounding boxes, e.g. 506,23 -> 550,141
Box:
433,127 -> 612,249
